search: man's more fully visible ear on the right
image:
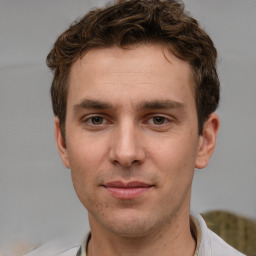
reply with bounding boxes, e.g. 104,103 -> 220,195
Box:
195,113 -> 220,169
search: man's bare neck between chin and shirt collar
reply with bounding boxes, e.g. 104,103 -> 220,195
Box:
88,210 -> 196,256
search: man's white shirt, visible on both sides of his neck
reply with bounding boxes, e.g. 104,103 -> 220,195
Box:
23,215 -> 245,256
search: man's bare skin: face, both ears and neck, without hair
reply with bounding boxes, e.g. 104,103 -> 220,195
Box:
55,44 -> 219,256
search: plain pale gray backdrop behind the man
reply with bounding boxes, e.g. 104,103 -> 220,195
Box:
0,0 -> 256,255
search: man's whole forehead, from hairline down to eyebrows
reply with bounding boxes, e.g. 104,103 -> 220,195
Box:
68,44 -> 194,107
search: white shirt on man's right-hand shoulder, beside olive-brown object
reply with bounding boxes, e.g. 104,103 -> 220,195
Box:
195,215 -> 245,256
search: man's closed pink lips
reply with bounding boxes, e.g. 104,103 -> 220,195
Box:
103,181 -> 154,200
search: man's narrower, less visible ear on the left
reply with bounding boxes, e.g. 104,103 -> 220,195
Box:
54,117 -> 70,168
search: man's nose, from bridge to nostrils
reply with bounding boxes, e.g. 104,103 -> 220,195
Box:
109,123 -> 146,168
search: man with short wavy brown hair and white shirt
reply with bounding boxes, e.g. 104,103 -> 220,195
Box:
27,0 -> 245,256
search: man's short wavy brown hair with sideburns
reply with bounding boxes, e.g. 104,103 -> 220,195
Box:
47,0 -> 220,137
